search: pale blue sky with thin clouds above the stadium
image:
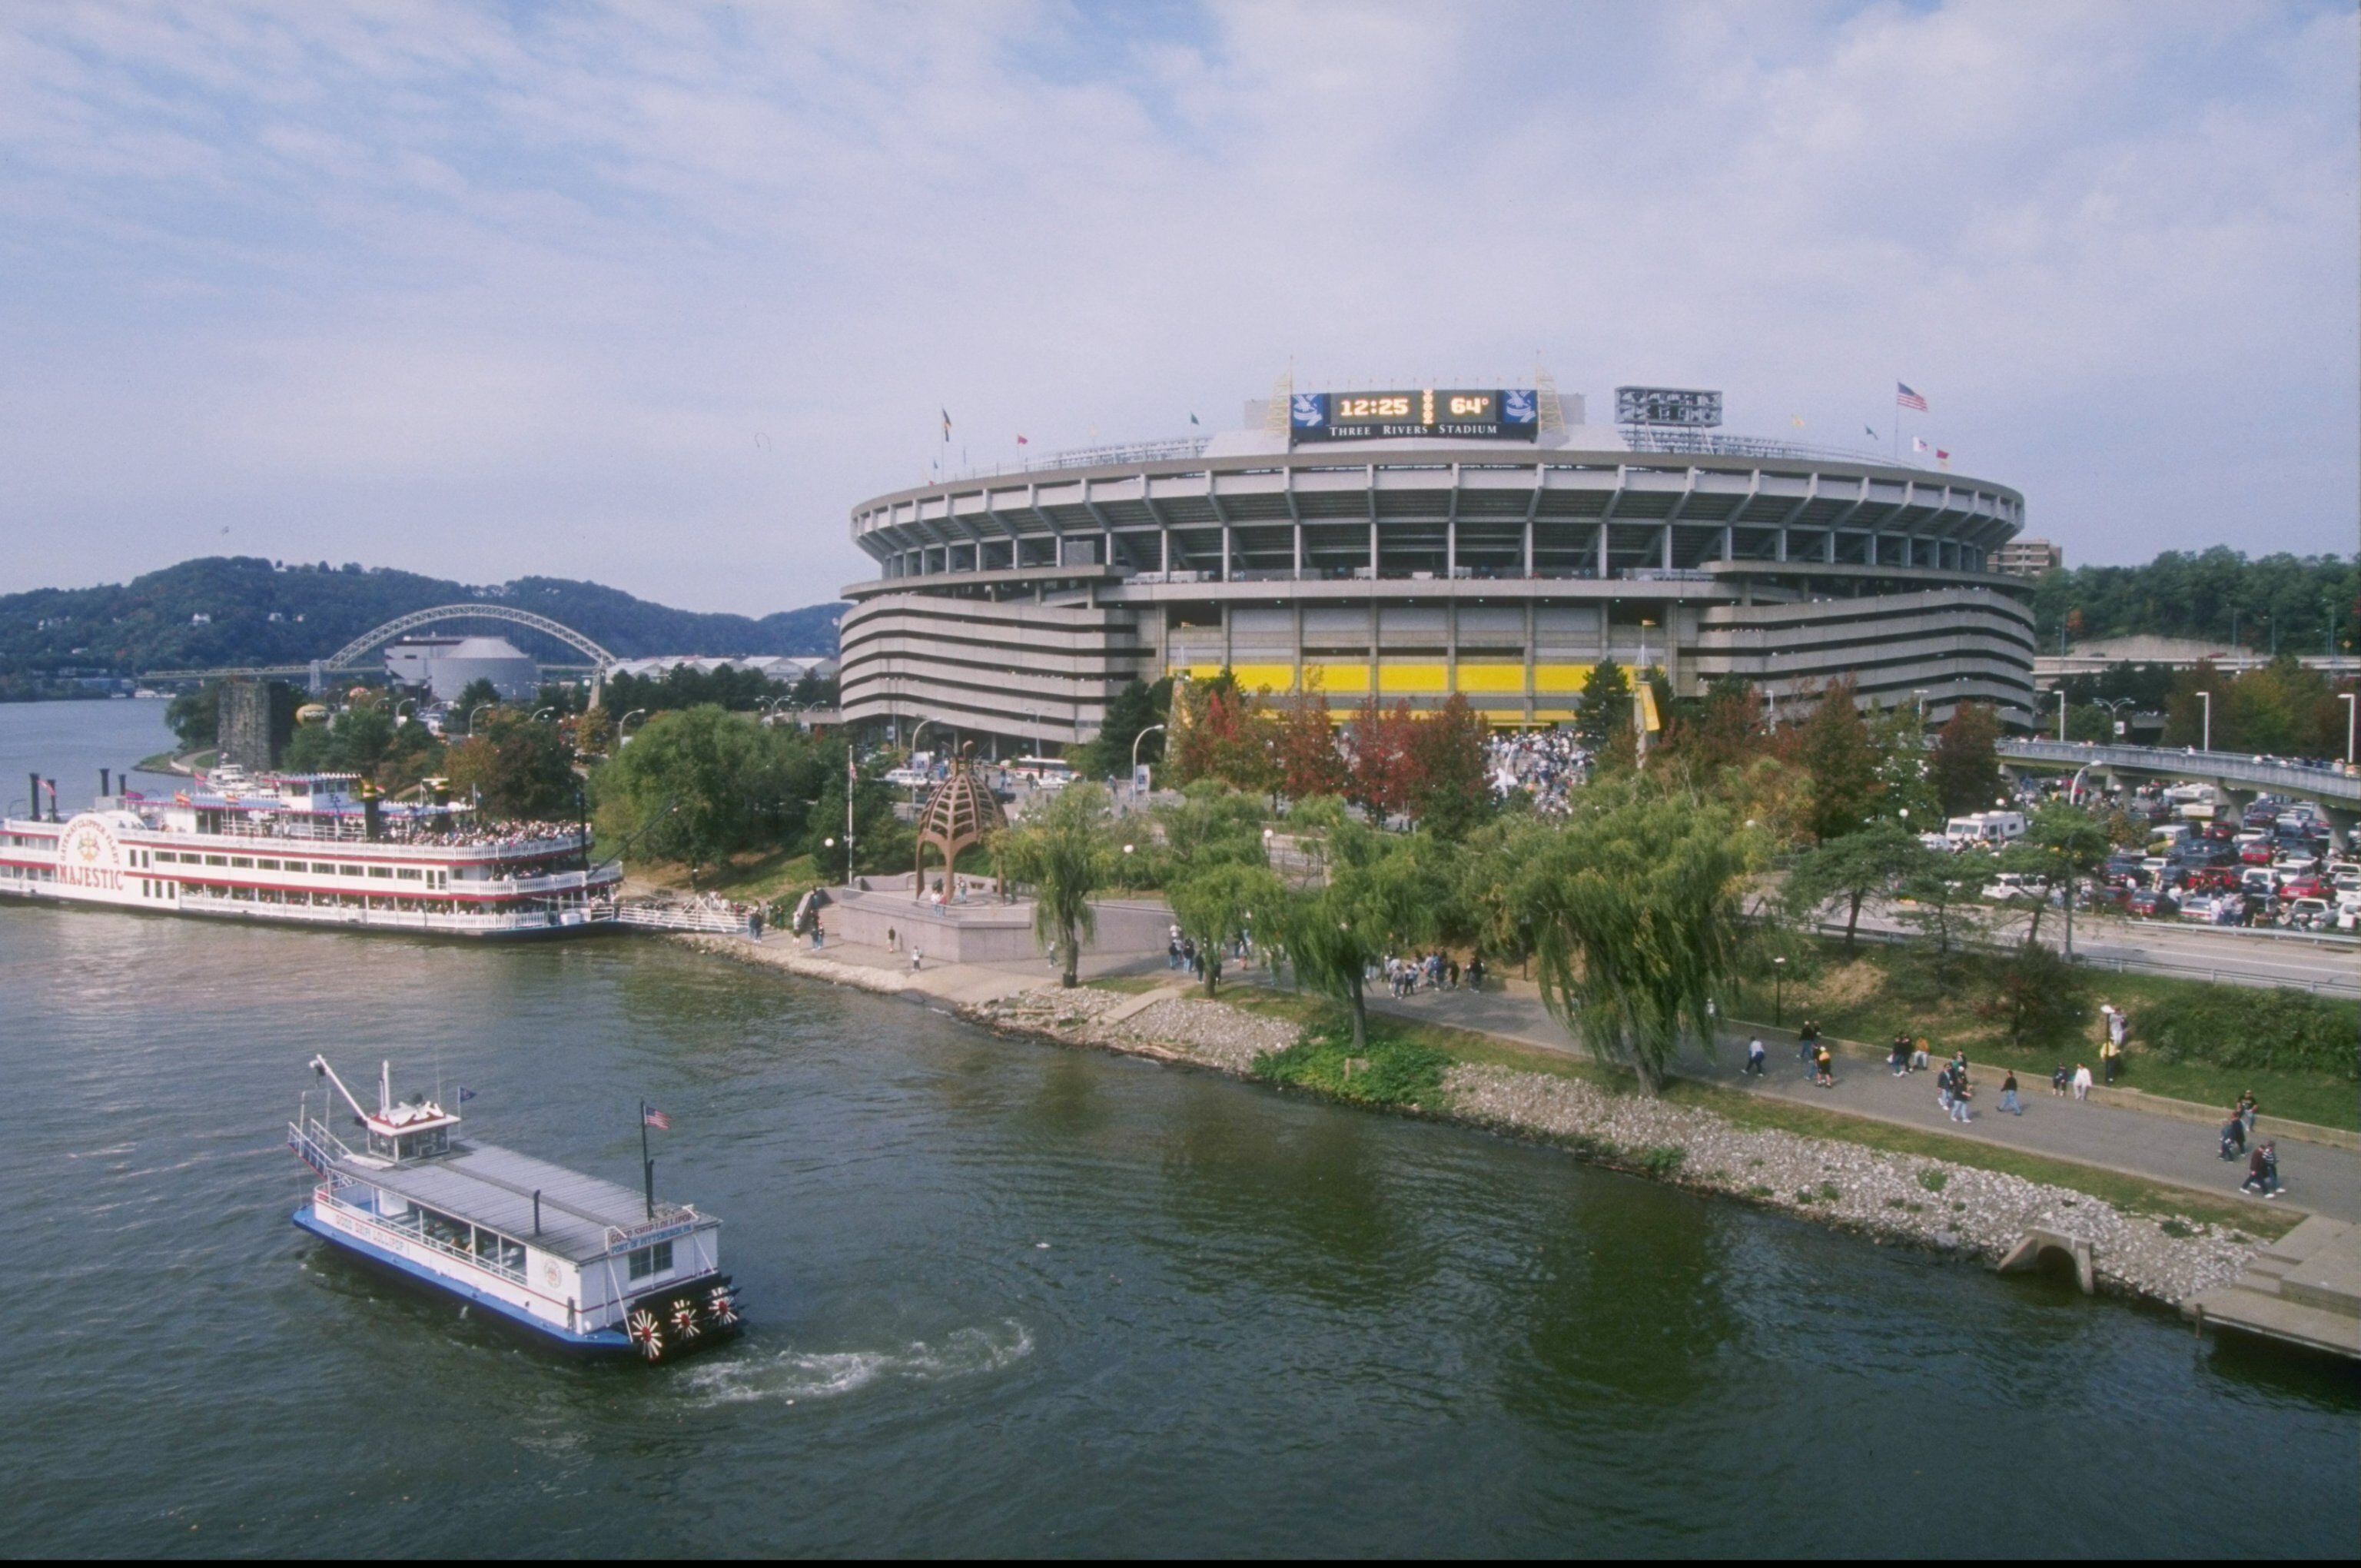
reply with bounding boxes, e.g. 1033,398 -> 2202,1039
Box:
0,0 -> 2361,614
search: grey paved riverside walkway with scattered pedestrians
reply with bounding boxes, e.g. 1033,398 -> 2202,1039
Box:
1370,980 -> 2361,1221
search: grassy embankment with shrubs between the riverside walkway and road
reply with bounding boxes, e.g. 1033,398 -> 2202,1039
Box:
1731,940 -> 2361,1129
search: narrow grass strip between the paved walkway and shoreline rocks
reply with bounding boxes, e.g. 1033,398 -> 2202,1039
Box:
1223,985 -> 2302,1240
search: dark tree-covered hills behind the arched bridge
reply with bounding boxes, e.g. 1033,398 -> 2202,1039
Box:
0,555 -> 843,696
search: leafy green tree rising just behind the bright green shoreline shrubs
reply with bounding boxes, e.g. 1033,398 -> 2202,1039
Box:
1284,819 -> 1452,1051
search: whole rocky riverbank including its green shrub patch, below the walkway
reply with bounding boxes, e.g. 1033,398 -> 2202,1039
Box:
682,938 -> 2276,1306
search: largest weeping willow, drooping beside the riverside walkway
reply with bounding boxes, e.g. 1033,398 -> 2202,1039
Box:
1509,784 -> 1752,1093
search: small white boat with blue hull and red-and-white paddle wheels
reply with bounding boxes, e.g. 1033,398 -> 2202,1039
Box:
288,1055 -> 739,1360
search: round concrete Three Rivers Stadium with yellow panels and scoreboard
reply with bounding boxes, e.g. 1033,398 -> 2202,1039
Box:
841,375 -> 2033,751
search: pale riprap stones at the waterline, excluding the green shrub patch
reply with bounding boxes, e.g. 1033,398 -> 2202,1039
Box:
958,987 -> 2260,1304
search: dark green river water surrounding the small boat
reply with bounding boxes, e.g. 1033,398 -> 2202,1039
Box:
0,701 -> 2361,1556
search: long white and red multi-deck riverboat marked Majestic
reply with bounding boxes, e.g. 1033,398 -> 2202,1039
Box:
0,770 -> 623,938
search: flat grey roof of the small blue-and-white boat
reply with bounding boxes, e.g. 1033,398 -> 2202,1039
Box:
333,1143 -> 720,1264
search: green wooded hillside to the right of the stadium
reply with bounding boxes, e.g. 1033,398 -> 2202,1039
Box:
2033,546 -> 2361,654
